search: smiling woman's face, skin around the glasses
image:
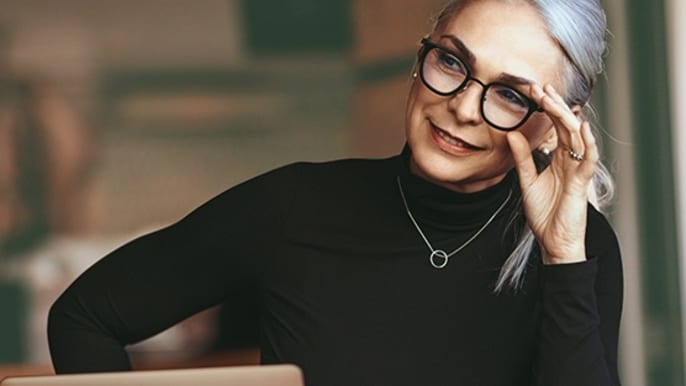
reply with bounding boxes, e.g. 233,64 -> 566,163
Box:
406,0 -> 564,192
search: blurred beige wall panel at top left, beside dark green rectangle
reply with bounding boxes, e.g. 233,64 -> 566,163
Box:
0,0 -> 243,73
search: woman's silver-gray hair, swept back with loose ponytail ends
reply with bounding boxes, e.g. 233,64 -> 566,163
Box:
434,0 -> 614,293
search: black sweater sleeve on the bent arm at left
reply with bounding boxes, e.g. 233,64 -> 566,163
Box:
48,164 -> 296,373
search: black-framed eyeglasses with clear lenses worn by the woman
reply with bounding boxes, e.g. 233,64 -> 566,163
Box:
419,38 -> 543,131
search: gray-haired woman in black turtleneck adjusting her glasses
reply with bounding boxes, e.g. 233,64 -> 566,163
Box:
49,0 -> 622,386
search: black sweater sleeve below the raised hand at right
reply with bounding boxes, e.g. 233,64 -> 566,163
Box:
537,211 -> 623,386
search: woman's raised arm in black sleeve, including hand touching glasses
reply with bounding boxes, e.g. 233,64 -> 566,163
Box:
507,85 -> 622,386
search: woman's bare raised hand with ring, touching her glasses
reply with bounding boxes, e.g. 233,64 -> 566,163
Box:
507,85 -> 598,264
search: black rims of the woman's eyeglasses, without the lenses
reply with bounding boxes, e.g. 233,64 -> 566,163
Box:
418,38 -> 543,131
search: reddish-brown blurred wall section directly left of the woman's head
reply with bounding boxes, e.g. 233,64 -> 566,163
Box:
349,0 -> 445,157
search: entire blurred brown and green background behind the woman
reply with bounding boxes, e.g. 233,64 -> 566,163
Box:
0,0 -> 686,386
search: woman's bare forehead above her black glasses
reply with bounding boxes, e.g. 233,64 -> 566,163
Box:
432,0 -> 564,87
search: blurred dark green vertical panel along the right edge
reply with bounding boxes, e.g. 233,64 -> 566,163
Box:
626,0 -> 684,385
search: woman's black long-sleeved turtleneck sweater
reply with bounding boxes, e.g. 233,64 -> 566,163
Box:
49,154 -> 622,386
